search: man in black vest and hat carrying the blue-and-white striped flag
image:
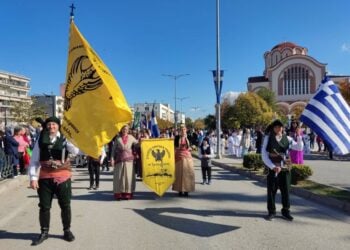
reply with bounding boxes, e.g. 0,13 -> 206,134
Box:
262,120 -> 300,221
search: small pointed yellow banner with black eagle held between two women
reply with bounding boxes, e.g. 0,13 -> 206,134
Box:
141,138 -> 175,196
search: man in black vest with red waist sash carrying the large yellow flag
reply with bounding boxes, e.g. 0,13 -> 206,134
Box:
29,117 -> 79,246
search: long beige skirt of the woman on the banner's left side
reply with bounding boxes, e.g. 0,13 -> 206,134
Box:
113,161 -> 136,194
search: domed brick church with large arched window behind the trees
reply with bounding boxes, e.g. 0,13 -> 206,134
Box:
247,42 -> 350,115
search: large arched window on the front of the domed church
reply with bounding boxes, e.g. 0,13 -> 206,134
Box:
283,65 -> 310,95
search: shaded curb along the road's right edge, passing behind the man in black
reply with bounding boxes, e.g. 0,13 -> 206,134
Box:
211,160 -> 350,214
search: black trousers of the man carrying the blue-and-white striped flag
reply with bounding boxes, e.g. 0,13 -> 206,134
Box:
267,170 -> 291,213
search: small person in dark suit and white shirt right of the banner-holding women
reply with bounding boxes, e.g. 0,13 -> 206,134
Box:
199,137 -> 214,185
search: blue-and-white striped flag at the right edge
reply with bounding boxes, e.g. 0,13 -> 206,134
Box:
300,77 -> 350,155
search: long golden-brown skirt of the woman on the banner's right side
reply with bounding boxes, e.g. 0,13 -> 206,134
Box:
173,157 -> 195,192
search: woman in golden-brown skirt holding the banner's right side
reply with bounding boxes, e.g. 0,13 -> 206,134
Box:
173,125 -> 195,197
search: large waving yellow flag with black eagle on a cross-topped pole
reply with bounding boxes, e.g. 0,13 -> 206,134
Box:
61,22 -> 131,158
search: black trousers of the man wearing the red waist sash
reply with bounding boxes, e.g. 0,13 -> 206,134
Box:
38,178 -> 72,232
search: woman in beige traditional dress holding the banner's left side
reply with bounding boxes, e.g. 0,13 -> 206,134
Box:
111,125 -> 138,200
